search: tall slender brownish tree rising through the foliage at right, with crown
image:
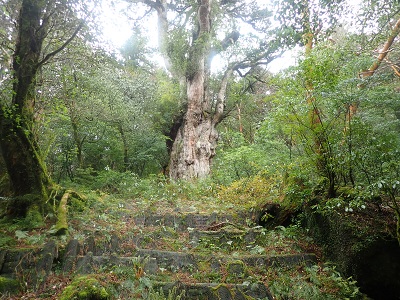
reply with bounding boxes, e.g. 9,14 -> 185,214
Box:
275,0 -> 345,196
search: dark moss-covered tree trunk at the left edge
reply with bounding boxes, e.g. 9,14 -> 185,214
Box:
0,0 -> 50,216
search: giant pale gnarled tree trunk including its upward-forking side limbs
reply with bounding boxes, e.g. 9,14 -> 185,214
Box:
147,0 -> 239,180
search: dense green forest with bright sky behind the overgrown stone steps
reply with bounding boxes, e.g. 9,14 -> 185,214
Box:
0,0 -> 400,299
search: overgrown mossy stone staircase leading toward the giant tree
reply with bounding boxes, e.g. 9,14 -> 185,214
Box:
0,212 -> 317,300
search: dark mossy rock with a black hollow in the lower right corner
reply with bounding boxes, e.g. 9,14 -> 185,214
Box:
306,208 -> 400,300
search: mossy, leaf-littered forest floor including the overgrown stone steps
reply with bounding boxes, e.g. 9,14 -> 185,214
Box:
0,180 -> 365,300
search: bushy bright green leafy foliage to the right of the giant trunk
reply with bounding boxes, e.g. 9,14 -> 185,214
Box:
256,32 -> 400,202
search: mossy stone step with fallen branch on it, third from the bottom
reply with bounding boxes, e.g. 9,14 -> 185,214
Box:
73,221 -> 290,256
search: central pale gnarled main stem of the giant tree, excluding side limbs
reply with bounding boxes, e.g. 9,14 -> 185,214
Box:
170,0 -> 218,180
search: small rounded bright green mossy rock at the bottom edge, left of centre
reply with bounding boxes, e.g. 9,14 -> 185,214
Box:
60,275 -> 110,300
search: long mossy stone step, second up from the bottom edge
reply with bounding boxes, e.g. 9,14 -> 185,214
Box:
70,249 -> 317,276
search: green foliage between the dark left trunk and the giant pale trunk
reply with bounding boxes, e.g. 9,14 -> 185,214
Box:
40,45 -> 166,182
